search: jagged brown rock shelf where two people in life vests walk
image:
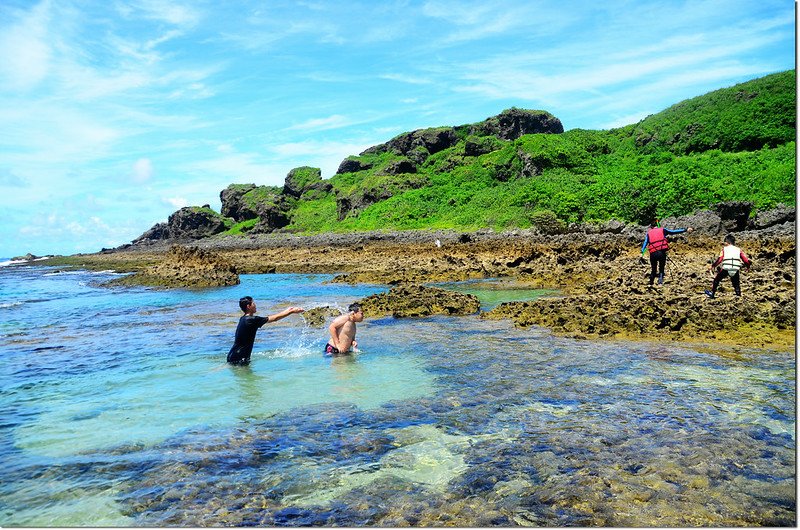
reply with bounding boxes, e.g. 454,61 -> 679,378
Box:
482,230 -> 796,348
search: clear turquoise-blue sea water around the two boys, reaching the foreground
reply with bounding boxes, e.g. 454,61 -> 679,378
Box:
0,266 -> 796,526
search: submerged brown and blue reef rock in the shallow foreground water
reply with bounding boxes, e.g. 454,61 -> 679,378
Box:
111,332 -> 795,527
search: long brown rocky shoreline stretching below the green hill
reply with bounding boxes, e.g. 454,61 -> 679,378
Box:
37,209 -> 796,350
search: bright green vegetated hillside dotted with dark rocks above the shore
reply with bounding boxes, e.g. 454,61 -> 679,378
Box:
166,71 -> 796,239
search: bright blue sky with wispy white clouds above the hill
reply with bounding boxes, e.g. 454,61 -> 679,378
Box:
0,0 -> 795,257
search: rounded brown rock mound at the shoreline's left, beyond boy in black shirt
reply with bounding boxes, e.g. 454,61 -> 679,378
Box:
110,245 -> 239,288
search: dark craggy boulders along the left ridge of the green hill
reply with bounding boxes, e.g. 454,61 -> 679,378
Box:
123,108 -> 564,248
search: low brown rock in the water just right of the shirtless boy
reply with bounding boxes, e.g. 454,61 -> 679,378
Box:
361,285 -> 480,317
